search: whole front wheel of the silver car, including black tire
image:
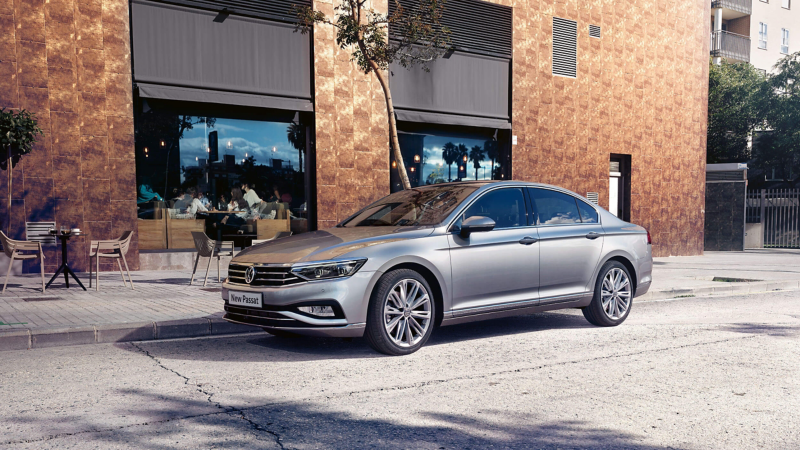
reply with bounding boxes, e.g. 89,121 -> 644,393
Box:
364,269 -> 436,356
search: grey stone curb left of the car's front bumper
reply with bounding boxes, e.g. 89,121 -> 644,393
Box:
0,317 -> 261,351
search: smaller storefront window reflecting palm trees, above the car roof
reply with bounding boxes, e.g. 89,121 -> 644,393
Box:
391,123 -> 511,192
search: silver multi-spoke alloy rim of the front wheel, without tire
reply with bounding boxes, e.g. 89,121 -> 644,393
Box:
383,278 -> 432,347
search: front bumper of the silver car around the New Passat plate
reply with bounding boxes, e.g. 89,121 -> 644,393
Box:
222,272 -> 375,337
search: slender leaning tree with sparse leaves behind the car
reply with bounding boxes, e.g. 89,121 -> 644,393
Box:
294,0 -> 450,189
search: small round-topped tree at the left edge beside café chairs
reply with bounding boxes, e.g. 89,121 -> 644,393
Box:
0,108 -> 44,235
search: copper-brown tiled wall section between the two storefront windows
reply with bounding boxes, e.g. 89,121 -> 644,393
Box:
314,0 -> 389,229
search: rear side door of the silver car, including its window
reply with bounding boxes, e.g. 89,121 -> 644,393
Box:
528,188 -> 603,304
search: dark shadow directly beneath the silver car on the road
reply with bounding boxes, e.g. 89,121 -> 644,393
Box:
126,312 -> 593,362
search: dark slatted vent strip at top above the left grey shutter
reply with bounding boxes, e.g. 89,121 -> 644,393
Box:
147,0 -> 311,23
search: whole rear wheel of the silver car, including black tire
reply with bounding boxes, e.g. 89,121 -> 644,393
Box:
582,261 -> 634,327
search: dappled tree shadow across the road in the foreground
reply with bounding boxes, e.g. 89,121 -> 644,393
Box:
0,388 -> 675,450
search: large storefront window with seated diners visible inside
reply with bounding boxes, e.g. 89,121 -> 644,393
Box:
136,100 -> 313,250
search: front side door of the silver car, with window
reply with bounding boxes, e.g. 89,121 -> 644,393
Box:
448,187 -> 539,315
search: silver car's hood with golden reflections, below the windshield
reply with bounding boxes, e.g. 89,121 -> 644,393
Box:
232,227 -> 433,264
